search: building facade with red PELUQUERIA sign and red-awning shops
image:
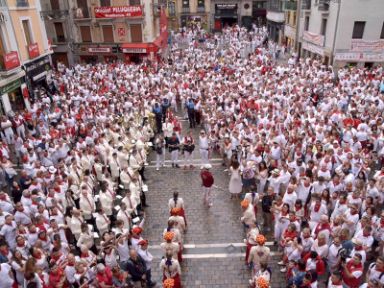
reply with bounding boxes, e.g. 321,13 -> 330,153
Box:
42,0 -> 164,65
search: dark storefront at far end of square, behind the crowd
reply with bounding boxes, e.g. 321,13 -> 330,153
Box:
213,3 -> 239,31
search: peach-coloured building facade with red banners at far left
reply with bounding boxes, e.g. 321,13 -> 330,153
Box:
0,0 -> 52,114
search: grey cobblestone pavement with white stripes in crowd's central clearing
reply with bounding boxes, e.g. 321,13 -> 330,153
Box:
144,118 -> 285,288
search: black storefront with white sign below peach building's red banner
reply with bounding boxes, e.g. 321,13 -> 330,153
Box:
23,55 -> 52,100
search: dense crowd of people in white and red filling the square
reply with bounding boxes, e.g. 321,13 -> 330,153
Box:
0,26 -> 384,288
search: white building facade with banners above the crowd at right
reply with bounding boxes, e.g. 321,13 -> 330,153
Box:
299,0 -> 384,66
